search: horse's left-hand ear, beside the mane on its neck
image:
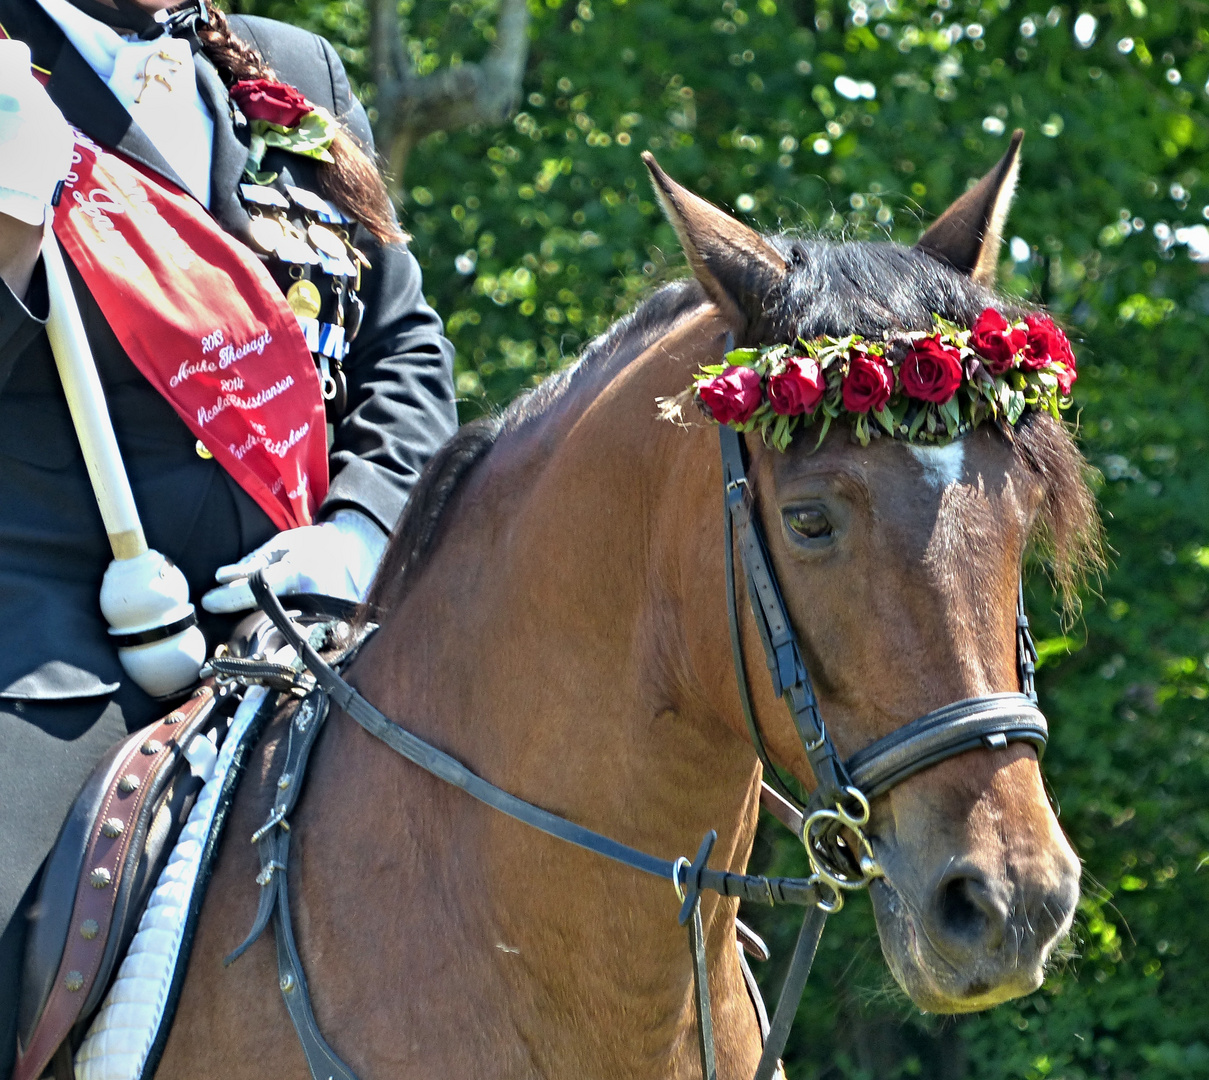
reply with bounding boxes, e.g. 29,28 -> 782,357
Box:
642,151 -> 789,325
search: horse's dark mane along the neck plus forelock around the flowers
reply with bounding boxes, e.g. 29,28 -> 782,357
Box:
363,233 -> 1103,618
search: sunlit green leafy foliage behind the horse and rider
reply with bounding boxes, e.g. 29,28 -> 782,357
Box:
235,0 -> 1209,1080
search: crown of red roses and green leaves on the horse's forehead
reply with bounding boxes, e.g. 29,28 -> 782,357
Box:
660,307 -> 1077,450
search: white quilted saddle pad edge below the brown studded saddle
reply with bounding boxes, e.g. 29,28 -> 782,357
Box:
75,687 -> 267,1080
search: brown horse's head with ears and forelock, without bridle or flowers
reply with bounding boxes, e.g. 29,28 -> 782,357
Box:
647,134 -> 1097,1012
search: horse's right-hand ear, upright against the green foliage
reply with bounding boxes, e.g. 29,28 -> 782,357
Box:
915,128 -> 1024,285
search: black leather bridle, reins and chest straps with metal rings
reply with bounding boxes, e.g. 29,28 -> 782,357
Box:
212,426 -> 1048,1080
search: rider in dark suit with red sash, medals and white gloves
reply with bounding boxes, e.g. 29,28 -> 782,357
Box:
0,0 -> 456,1064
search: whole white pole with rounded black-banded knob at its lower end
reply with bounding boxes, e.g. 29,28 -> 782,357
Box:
42,225 -> 206,698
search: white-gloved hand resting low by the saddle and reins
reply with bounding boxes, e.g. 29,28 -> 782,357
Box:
202,510 -> 387,614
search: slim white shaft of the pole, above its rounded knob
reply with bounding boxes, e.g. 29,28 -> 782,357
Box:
42,229 -> 147,559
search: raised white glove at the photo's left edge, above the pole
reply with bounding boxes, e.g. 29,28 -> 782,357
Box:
0,41 -> 75,225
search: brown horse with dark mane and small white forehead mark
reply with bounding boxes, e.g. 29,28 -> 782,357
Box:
158,145 -> 1097,1080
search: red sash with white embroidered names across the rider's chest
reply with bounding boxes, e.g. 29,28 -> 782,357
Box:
54,131 -> 328,529
